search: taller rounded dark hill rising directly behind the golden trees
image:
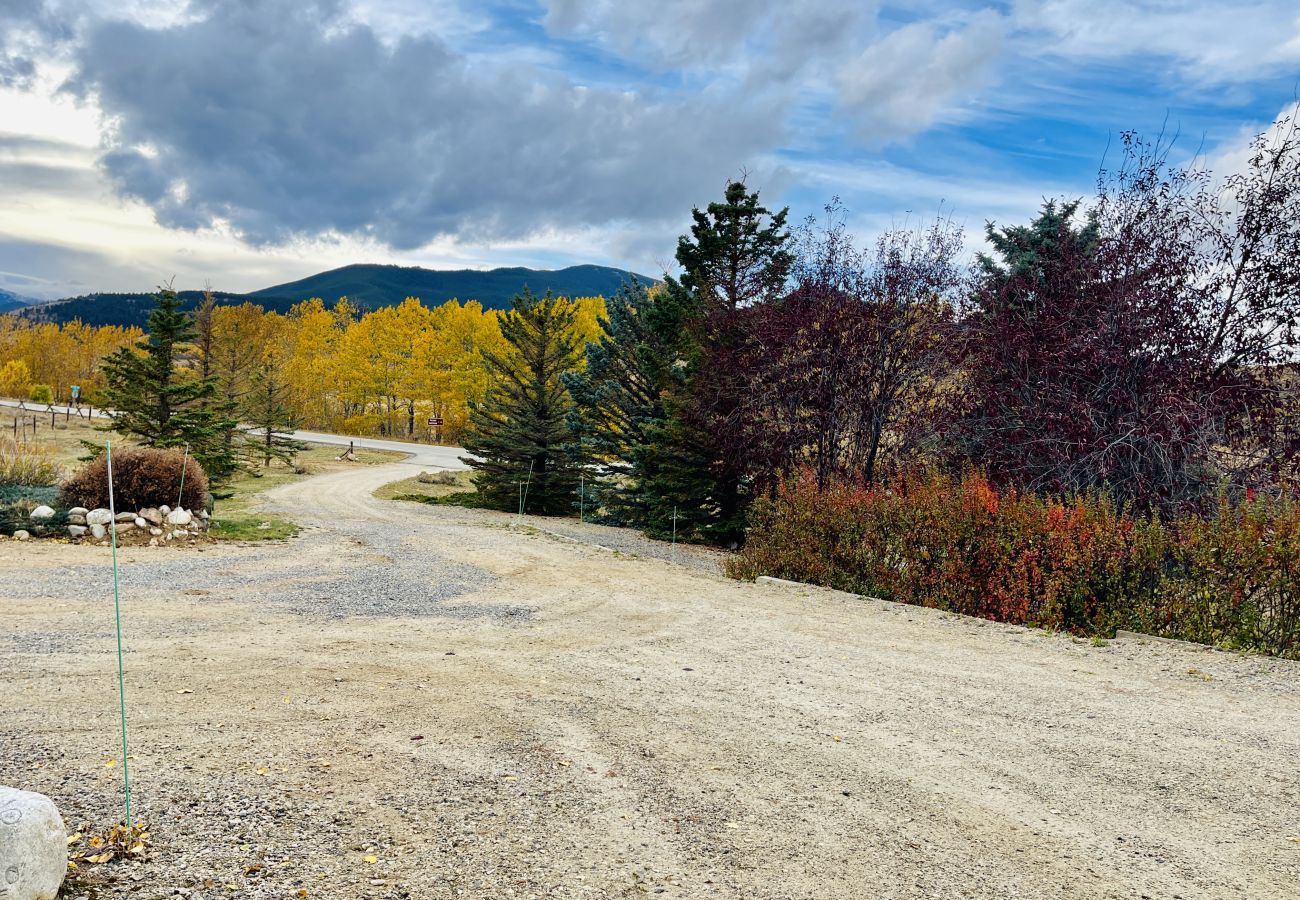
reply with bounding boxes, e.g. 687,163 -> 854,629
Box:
250,264 -> 654,310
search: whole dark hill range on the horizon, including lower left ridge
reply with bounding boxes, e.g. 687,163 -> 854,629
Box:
27,264 -> 654,328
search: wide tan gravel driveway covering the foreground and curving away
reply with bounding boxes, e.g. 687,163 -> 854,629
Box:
0,466 -> 1300,900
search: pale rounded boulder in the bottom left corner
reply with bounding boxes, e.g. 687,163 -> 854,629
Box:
0,787 -> 68,900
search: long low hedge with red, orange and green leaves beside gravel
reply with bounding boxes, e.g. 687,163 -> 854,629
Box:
728,472 -> 1300,658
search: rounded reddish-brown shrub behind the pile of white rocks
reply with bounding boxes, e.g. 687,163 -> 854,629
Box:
62,447 -> 208,511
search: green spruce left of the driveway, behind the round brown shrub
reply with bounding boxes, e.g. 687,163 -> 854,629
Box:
103,287 -> 238,484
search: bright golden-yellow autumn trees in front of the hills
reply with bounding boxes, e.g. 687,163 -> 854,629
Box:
0,297 -> 606,443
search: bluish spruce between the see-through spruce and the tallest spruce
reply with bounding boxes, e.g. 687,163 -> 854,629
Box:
564,280 -> 664,527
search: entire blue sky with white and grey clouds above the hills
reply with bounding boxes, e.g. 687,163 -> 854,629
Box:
0,0 -> 1300,298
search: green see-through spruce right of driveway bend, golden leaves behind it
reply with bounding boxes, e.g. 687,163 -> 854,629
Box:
464,287 -> 579,515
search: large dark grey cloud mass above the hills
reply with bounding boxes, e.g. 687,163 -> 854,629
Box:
73,0 -> 781,248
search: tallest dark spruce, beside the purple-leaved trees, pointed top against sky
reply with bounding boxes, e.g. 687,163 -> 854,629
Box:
641,182 -> 794,544
